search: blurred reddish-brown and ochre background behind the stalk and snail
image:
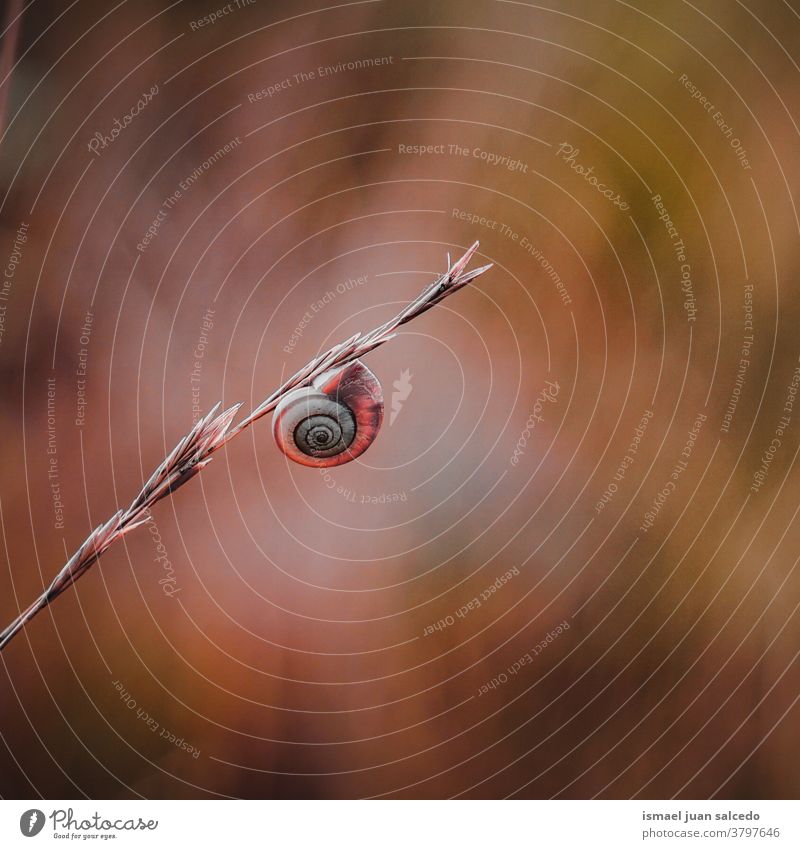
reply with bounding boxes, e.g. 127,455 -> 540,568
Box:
0,0 -> 800,798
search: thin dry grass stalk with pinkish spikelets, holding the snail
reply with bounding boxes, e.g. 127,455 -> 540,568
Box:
0,242 -> 491,650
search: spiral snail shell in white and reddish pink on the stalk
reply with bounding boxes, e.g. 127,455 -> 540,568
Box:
272,360 -> 383,468
